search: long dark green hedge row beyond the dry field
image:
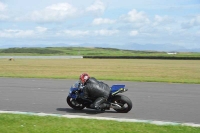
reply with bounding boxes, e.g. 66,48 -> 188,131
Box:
83,56 -> 200,60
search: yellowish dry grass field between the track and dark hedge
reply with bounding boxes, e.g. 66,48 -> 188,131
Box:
0,59 -> 200,84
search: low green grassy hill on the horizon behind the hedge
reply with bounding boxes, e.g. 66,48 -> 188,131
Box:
0,47 -> 200,57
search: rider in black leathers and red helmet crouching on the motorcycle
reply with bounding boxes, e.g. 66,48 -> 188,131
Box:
80,73 -> 110,110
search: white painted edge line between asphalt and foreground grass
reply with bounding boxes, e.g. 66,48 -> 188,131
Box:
0,110 -> 200,127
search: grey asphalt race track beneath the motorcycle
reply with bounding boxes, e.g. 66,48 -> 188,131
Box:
0,78 -> 200,124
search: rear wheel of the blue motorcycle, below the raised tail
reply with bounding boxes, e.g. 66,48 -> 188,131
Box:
111,95 -> 132,113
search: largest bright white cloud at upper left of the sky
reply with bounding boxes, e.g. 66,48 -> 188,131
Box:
31,3 -> 77,22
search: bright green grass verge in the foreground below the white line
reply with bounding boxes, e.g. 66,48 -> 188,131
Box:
0,114 -> 200,133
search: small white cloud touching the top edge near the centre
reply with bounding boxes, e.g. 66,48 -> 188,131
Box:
86,0 -> 106,13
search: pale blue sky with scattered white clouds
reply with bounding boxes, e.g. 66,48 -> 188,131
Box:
0,0 -> 200,50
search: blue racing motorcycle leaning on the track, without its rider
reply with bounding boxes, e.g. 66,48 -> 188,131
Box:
66,81 -> 132,113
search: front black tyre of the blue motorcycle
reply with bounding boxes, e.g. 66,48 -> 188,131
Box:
66,96 -> 85,110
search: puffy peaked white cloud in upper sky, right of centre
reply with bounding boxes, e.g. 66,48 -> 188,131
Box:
120,9 -> 150,23
